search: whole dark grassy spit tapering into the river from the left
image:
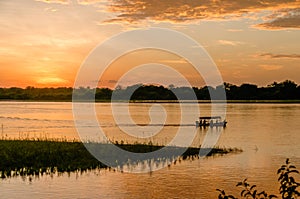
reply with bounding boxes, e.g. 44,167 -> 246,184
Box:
0,140 -> 241,178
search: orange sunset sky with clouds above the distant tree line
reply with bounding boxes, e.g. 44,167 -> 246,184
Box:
0,0 -> 300,87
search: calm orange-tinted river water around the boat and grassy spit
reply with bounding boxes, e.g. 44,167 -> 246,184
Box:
0,102 -> 300,198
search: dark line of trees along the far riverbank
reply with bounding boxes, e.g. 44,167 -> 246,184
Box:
0,80 -> 300,101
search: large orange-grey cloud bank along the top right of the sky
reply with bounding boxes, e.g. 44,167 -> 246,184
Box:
103,0 -> 300,23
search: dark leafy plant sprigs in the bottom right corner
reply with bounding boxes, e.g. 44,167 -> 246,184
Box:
217,159 -> 300,199
